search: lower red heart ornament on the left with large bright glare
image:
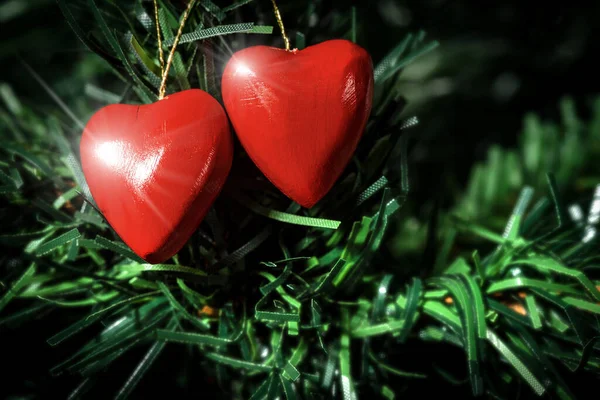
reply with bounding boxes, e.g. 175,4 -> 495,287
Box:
80,89 -> 233,263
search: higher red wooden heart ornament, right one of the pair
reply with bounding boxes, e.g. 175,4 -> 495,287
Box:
222,40 -> 373,208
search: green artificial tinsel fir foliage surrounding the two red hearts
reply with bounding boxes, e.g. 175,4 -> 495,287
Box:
0,0 -> 600,400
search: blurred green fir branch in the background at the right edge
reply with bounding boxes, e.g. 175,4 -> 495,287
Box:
454,97 -> 600,223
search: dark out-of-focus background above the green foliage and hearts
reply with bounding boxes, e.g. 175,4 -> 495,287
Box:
0,0 -> 600,186
